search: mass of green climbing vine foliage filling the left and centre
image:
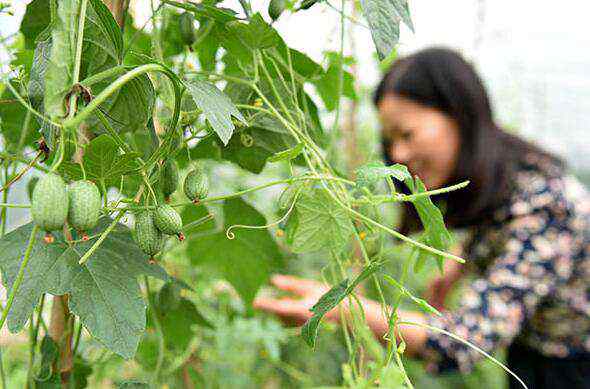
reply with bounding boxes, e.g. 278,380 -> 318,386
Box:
0,0 -> 490,388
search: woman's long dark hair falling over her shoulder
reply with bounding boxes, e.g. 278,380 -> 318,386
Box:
374,47 -> 563,232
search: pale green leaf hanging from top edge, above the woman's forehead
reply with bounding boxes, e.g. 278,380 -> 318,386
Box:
361,0 -> 400,60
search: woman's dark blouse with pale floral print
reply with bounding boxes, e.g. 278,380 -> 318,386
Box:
423,152 -> 590,372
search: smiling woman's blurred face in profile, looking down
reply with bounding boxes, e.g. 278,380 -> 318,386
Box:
378,94 -> 460,189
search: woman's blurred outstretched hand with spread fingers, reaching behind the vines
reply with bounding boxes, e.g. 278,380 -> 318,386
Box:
254,274 -> 338,325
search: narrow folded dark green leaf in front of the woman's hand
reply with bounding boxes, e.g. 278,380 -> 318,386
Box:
301,262 -> 383,348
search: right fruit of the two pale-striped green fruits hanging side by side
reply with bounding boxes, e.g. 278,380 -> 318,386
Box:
68,180 -> 101,240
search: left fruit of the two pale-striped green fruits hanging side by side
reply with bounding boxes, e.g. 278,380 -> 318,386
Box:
31,173 -> 68,243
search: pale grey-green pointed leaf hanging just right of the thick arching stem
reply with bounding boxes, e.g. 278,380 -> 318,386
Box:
185,79 -> 246,145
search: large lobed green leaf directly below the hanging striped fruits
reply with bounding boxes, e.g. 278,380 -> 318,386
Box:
0,218 -> 168,358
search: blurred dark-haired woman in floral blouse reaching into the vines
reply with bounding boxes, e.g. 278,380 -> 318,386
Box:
255,48 -> 590,388
